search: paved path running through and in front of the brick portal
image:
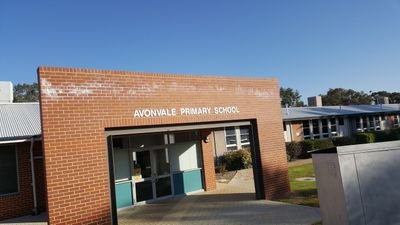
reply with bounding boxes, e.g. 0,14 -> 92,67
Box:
119,169 -> 321,225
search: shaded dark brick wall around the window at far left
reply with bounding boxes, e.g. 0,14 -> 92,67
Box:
0,142 -> 45,220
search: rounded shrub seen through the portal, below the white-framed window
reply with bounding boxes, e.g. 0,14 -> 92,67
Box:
222,150 -> 252,171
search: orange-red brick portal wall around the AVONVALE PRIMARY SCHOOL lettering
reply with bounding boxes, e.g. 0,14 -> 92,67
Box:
38,67 -> 289,224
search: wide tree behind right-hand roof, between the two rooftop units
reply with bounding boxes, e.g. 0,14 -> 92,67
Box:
322,88 -> 373,106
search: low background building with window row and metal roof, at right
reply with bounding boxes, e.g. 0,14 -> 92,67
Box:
282,96 -> 400,142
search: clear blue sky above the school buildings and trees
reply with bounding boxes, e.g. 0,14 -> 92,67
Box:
0,0 -> 400,97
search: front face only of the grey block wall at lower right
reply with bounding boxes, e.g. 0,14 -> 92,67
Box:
339,141 -> 400,224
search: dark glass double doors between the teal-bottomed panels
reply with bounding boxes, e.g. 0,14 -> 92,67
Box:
132,148 -> 172,202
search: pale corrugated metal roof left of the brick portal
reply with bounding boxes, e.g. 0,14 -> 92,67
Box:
0,103 -> 42,141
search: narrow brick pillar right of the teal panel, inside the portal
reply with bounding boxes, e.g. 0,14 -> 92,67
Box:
200,130 -> 217,191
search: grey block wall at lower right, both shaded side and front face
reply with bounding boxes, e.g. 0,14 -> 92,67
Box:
313,141 -> 400,225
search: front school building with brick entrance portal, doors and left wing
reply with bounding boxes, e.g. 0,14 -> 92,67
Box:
0,67 -> 289,224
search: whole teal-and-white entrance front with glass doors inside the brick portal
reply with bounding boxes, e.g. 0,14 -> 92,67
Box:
109,131 -> 203,209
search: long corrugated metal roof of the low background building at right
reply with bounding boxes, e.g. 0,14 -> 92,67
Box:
282,104 -> 400,121
